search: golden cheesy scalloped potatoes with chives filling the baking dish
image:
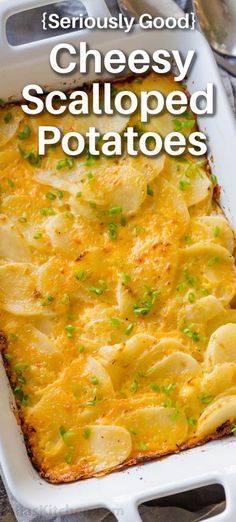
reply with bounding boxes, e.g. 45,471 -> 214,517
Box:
0,74 -> 236,482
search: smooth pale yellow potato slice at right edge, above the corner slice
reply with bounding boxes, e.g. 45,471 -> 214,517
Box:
205,323 -> 236,367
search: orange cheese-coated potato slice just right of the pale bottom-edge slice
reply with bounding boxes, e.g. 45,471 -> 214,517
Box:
116,407 -> 188,453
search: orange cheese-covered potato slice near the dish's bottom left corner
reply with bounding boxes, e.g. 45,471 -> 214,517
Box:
28,356 -> 115,428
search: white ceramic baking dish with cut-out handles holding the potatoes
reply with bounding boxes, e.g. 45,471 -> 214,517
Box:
0,0 -> 236,522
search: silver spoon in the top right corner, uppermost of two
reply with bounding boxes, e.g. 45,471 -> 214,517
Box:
193,0 -> 236,76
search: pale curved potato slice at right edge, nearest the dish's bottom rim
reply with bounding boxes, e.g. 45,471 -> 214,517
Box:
196,395 -> 236,438
